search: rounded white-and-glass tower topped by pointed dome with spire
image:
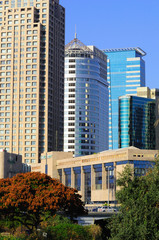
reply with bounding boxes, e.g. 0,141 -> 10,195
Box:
64,37 -> 108,156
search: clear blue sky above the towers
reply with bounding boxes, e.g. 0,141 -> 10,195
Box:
60,0 -> 159,88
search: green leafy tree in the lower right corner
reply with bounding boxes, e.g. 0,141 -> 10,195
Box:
110,161 -> 159,240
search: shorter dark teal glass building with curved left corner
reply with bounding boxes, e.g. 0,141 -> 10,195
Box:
119,95 -> 156,149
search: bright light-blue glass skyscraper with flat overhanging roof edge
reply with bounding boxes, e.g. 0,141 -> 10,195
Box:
104,47 -> 146,149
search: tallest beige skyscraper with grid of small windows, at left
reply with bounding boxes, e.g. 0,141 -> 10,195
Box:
0,0 -> 65,163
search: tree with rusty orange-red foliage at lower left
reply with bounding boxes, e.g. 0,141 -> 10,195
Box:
0,173 -> 86,231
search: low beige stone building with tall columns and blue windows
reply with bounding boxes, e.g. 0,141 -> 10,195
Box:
32,147 -> 159,204
